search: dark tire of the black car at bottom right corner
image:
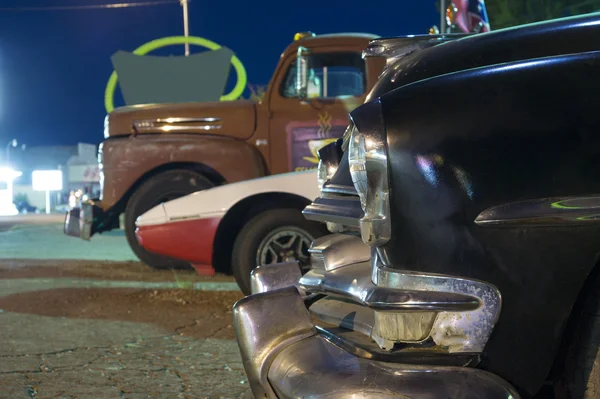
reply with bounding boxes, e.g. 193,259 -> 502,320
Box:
555,270 -> 600,399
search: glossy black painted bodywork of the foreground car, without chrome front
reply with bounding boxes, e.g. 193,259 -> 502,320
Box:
312,13 -> 600,396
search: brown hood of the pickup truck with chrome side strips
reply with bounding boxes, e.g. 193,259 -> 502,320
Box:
104,100 -> 256,139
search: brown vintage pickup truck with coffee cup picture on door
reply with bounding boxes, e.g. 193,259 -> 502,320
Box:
65,33 -> 385,268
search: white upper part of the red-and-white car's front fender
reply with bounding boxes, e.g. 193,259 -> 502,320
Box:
136,169 -> 319,227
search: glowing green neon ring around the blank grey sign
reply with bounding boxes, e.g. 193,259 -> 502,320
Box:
104,36 -> 247,113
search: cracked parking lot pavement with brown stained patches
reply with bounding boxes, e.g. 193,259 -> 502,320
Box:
0,219 -> 252,399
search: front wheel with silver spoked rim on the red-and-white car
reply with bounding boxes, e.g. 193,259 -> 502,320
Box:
232,208 -> 327,295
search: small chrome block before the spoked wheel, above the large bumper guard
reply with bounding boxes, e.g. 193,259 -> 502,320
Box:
250,262 -> 304,295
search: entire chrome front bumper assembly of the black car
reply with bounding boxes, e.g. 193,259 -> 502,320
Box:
234,235 -> 519,399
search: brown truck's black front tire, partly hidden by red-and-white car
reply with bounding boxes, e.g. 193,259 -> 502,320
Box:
125,170 -> 214,269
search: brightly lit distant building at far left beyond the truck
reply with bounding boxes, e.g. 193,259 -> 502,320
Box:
7,143 -> 100,209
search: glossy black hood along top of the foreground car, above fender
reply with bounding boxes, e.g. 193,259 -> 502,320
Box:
367,13 -> 600,102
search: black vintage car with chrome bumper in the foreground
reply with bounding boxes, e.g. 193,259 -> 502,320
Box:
234,14 -> 600,398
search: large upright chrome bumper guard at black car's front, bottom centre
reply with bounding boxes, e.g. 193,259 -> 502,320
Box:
233,287 -> 316,399
